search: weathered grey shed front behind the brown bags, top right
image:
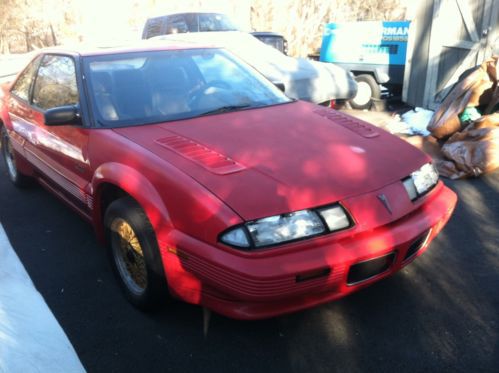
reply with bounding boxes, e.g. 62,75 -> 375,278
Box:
402,0 -> 499,109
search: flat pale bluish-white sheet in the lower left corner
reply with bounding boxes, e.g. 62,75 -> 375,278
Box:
0,225 -> 85,373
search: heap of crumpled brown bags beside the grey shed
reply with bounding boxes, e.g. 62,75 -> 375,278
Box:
427,56 -> 499,179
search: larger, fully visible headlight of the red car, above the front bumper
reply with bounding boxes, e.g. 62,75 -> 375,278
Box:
220,205 -> 351,249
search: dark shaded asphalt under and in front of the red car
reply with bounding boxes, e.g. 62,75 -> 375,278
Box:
0,158 -> 499,373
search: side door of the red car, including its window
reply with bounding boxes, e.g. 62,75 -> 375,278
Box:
24,54 -> 92,211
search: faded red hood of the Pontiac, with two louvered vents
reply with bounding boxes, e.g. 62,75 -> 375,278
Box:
115,102 -> 428,220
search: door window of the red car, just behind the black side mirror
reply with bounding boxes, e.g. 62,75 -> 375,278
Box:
33,55 -> 78,110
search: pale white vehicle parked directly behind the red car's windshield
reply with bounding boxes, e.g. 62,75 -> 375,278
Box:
153,31 -> 357,103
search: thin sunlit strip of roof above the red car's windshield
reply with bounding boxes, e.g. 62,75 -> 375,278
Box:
35,40 -> 214,56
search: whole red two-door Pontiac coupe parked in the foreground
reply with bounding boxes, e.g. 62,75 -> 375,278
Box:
0,44 -> 457,319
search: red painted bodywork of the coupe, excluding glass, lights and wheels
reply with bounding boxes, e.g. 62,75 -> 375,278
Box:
0,47 -> 457,319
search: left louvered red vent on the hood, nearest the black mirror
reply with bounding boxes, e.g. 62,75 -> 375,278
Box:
156,135 -> 245,175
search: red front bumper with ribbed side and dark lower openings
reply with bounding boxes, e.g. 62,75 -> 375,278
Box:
160,183 -> 457,319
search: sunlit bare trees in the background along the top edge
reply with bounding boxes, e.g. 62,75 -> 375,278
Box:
0,0 -> 404,56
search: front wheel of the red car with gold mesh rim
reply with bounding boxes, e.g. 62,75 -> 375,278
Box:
104,197 -> 168,310
